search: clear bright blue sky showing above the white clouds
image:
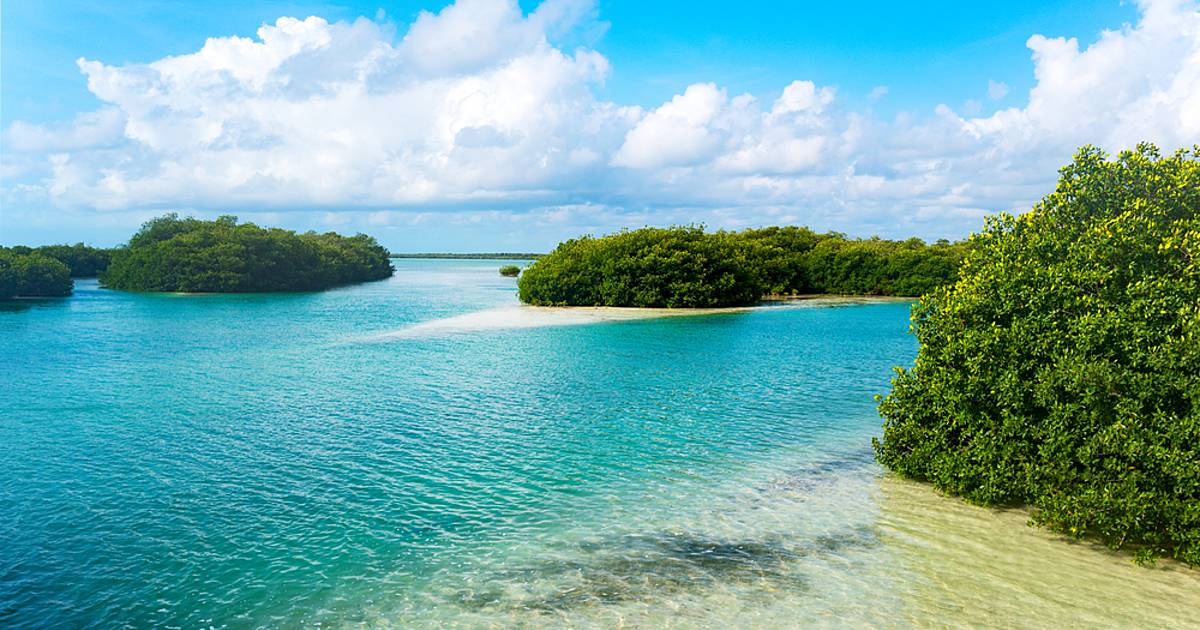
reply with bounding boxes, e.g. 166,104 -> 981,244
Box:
0,0 -> 1136,126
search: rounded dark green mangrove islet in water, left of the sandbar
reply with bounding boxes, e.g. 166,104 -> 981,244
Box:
101,214 -> 392,293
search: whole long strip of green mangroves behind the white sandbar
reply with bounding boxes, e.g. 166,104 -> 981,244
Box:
518,227 -> 966,308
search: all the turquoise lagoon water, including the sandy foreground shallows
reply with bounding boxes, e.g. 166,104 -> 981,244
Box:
0,260 -> 1200,628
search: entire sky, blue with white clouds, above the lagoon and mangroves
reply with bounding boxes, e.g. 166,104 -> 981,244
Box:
0,0 -> 1200,251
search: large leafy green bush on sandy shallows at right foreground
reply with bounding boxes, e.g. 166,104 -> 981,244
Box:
875,145 -> 1200,564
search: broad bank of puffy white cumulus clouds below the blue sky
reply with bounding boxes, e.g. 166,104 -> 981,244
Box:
0,0 -> 1200,243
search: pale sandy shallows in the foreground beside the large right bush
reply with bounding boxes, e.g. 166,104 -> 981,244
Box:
357,454 -> 1200,630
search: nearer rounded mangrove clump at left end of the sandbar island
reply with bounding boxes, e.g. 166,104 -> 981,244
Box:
517,228 -> 763,308
